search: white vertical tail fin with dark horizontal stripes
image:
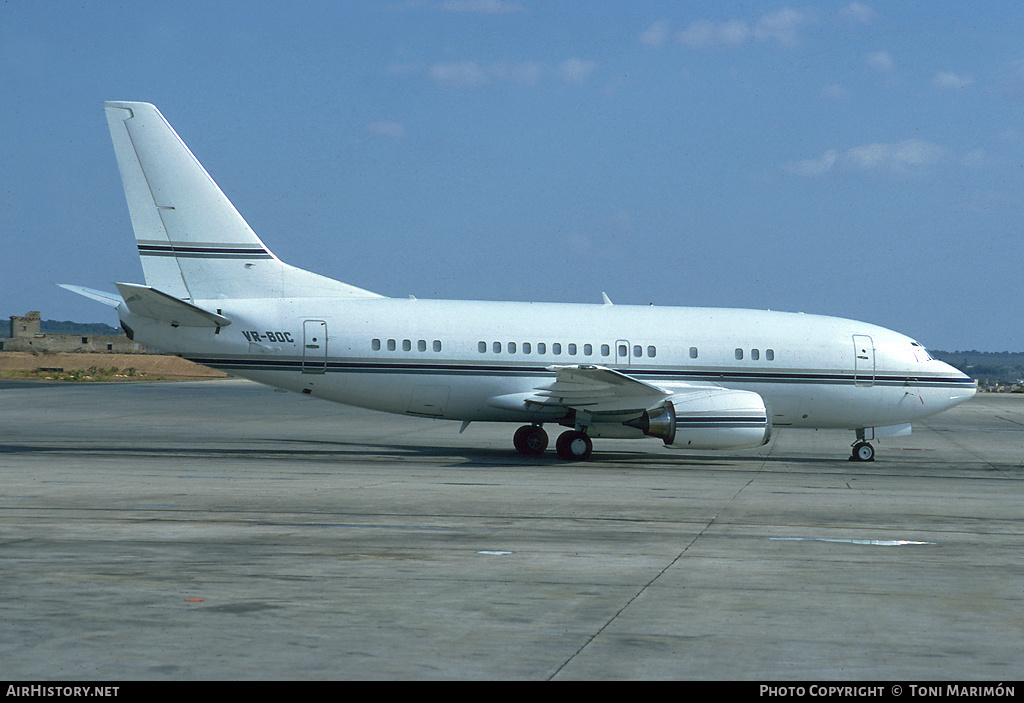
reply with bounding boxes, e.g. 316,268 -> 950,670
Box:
103,102 -> 379,300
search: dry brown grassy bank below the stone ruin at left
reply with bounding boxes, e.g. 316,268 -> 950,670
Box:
0,352 -> 227,382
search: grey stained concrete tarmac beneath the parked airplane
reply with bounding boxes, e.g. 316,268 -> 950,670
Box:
0,381 -> 1024,683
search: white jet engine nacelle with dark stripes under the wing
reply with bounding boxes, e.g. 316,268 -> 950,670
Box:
626,388 -> 771,449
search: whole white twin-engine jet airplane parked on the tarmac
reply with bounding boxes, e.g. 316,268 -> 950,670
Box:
65,102 -> 977,462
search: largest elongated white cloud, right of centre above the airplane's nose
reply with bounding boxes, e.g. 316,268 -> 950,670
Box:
782,139 -> 950,177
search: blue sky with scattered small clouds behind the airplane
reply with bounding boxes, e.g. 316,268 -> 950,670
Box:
0,0 -> 1024,351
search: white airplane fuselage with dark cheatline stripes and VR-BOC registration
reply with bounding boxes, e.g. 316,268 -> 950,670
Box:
120,298 -> 975,436
